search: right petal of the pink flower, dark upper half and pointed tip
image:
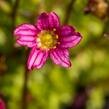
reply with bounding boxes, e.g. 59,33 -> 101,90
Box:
59,26 -> 82,48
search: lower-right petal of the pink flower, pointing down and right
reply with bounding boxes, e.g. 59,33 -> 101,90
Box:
50,49 -> 71,67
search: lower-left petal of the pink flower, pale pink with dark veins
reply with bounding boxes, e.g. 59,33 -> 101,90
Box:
27,47 -> 48,70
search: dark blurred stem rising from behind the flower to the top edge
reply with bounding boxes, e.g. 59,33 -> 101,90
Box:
64,0 -> 76,24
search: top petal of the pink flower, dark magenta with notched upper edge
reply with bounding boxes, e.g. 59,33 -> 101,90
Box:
37,12 -> 60,30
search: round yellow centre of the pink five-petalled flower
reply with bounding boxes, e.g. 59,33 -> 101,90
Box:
37,30 -> 58,50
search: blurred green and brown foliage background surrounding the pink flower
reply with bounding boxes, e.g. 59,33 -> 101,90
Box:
0,0 -> 109,109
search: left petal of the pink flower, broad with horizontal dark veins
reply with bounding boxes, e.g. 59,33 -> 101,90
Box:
14,24 -> 38,47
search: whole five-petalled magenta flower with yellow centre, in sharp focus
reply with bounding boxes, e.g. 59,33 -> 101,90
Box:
14,12 -> 82,70
